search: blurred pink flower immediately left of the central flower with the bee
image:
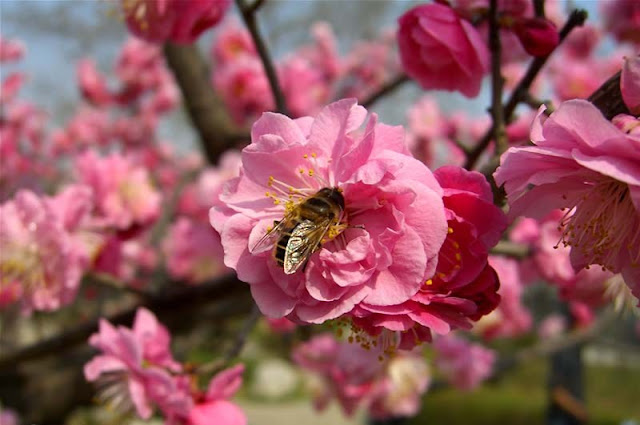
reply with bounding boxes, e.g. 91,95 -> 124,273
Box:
163,217 -> 229,283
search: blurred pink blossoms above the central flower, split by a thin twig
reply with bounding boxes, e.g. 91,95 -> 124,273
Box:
211,21 -> 400,125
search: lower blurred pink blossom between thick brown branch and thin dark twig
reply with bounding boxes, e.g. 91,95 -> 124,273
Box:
213,56 -> 274,124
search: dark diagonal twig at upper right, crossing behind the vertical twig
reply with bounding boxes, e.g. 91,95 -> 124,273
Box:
464,9 -> 587,170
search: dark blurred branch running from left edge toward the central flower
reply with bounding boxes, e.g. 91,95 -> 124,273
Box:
0,274 -> 249,370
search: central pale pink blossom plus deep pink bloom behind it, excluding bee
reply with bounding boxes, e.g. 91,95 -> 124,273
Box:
210,99 -> 506,348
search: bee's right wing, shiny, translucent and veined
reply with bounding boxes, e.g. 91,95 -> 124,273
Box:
283,219 -> 331,274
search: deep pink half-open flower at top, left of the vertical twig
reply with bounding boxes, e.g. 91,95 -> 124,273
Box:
398,3 -> 489,97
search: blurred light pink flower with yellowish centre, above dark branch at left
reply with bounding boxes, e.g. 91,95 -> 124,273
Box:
76,151 -> 162,230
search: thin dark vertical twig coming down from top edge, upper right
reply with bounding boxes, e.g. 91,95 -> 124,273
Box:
489,0 -> 507,156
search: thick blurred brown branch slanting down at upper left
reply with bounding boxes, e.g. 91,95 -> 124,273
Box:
164,43 -> 249,164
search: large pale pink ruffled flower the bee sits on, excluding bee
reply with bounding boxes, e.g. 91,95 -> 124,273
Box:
210,99 -> 447,323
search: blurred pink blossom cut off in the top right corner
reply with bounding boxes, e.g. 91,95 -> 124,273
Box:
600,0 -> 640,43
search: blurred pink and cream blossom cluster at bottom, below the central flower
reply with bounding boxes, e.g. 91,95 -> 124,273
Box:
292,334 -> 430,419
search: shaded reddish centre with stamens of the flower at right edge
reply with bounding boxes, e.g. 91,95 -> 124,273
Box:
556,179 -> 640,271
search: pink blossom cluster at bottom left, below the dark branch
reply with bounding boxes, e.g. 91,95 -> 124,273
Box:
84,308 -> 247,425
